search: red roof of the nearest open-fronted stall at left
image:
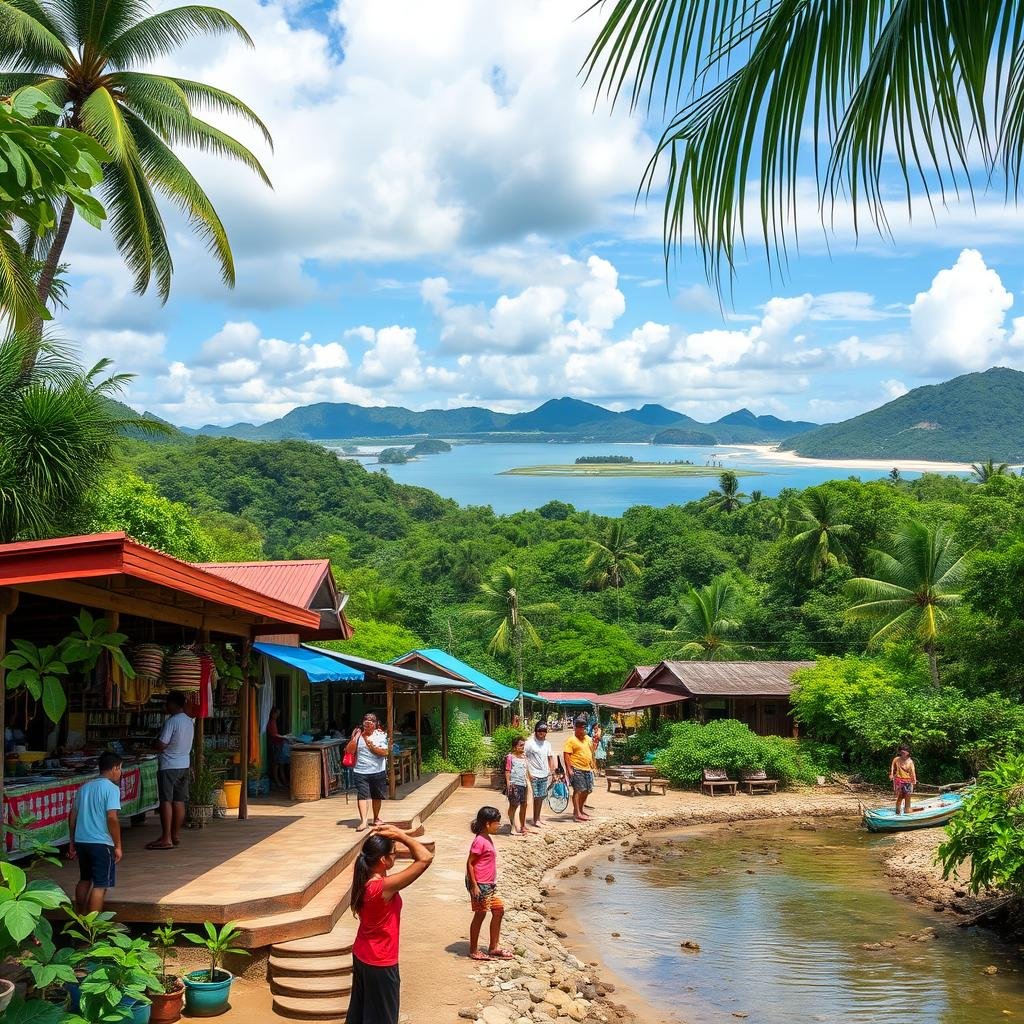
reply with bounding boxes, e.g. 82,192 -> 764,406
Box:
0,532 -> 319,630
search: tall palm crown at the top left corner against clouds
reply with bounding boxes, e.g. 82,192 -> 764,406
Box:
0,0 -> 270,317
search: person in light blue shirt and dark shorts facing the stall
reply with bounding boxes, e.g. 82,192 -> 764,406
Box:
68,751 -> 122,913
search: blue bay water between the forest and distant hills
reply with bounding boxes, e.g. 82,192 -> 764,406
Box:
366,444 -> 966,515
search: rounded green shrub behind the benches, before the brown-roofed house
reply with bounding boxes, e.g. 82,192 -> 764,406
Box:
654,719 -> 818,785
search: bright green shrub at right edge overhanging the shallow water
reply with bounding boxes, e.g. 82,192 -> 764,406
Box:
939,754 -> 1024,896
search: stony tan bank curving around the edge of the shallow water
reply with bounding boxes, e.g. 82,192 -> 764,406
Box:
459,790 -> 858,1024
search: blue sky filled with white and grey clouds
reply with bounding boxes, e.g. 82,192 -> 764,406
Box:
56,0 -> 1024,426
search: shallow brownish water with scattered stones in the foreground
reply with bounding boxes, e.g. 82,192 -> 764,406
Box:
553,820 -> 1024,1024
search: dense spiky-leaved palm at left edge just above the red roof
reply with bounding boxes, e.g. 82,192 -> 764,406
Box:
0,333 -> 157,543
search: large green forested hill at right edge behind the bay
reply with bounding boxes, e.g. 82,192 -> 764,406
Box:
782,367 -> 1024,463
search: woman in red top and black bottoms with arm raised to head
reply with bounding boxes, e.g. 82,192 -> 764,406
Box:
345,825 -> 434,1024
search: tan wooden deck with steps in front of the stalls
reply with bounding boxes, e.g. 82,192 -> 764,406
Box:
39,775 -> 459,947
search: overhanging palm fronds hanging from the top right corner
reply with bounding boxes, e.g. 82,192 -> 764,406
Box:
584,0 -> 1024,287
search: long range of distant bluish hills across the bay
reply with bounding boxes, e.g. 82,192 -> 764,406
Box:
180,398 -> 817,444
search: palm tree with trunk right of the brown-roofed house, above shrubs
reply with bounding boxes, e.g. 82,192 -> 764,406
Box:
847,522 -> 966,686
